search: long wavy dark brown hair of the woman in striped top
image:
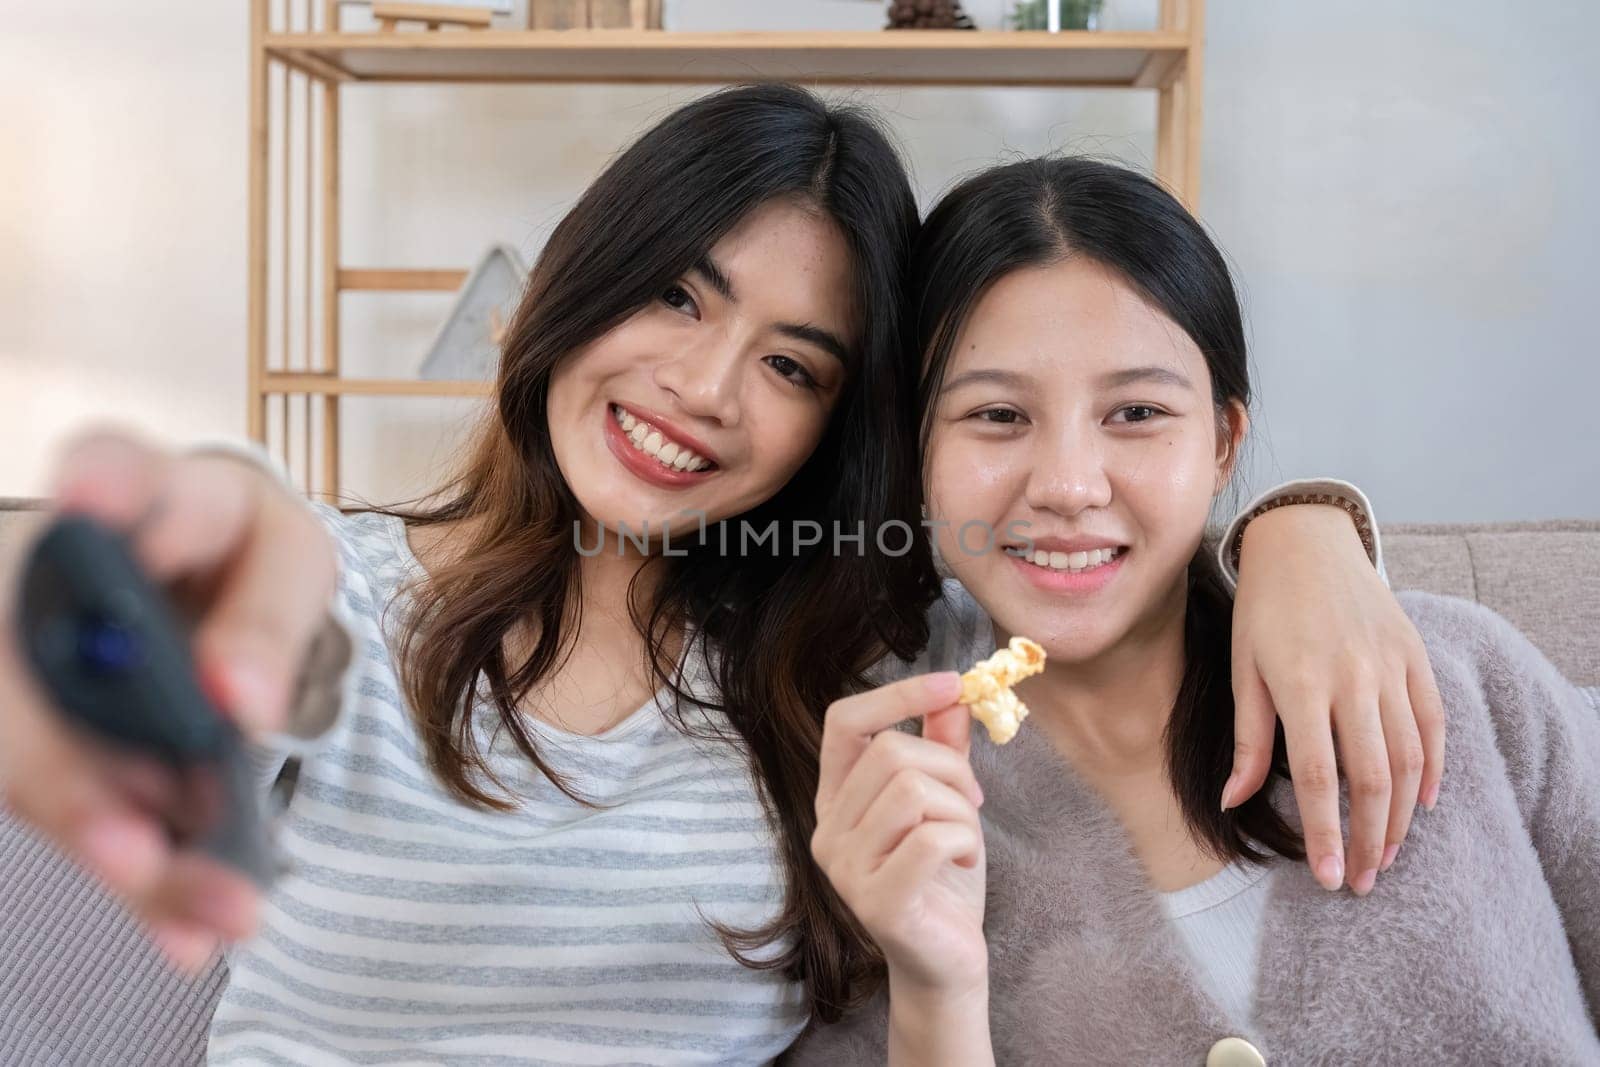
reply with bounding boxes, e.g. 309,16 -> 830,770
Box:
339,85 -> 938,1019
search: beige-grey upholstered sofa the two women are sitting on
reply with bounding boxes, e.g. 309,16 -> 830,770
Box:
0,499 -> 1600,1067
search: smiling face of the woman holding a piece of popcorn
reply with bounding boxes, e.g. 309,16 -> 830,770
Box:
926,256 -> 1246,664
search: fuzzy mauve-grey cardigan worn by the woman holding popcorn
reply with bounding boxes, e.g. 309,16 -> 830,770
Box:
784,593 -> 1600,1067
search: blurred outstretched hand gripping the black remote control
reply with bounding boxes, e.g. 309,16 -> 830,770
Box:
0,429 -> 336,971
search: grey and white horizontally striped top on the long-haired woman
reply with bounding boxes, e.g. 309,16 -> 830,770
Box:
210,506 -> 805,1065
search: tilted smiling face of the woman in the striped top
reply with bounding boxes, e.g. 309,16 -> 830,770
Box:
549,198 -> 853,543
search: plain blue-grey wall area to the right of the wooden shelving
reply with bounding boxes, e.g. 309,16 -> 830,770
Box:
1202,0 -> 1600,522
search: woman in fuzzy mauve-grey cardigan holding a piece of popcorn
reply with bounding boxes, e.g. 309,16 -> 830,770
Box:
790,158 -> 1600,1067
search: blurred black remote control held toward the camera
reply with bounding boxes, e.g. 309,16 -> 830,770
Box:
16,515 -> 277,888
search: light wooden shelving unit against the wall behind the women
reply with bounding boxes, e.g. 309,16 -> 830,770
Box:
248,0 -> 1205,493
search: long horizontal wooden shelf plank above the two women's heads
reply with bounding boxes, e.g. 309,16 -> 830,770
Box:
264,30 -> 1190,86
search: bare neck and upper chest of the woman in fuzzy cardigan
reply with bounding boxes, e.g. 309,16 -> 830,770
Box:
995,581 -> 1187,781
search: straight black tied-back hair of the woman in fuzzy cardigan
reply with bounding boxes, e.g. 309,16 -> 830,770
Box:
912,157 -> 1306,861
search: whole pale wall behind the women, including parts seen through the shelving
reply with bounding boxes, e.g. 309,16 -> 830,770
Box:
0,0 -> 1600,522
